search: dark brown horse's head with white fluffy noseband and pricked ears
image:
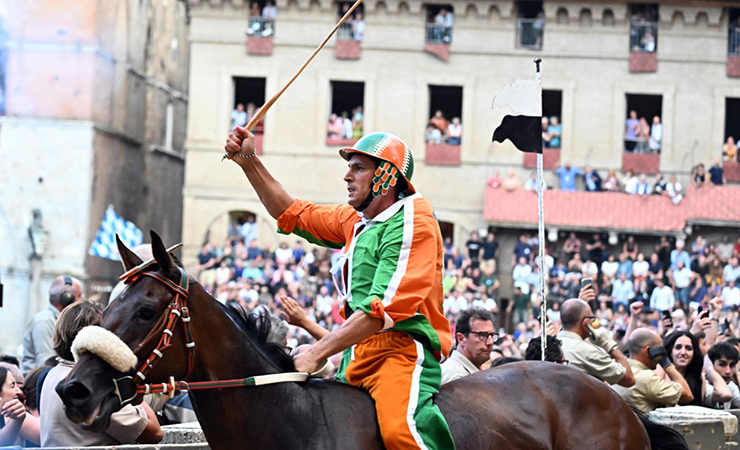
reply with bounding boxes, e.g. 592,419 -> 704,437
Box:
56,232 -> 190,431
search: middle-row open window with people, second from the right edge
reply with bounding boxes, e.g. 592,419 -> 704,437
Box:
624,94 -> 663,153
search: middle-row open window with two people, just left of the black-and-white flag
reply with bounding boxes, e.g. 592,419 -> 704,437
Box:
426,86 -> 463,145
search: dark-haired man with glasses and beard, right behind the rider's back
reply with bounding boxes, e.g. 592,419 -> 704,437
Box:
442,308 -> 498,384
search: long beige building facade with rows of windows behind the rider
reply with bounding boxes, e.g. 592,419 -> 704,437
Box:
183,0 -> 740,263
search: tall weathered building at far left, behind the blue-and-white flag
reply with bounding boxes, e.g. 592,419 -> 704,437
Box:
0,0 -> 189,353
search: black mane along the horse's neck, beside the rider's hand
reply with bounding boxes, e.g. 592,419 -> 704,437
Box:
214,299 -> 295,372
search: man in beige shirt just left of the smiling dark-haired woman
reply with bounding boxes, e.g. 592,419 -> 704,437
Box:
614,328 -> 693,413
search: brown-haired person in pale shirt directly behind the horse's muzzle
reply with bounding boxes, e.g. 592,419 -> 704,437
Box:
39,302 -> 162,447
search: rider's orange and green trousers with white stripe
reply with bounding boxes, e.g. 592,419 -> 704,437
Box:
338,331 -> 455,450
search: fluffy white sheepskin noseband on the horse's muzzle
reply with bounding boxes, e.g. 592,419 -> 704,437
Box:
72,326 -> 138,373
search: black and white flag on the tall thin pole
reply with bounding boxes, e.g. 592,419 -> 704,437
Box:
493,80 -> 542,153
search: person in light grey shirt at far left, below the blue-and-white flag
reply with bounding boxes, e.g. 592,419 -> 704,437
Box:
21,276 -> 83,373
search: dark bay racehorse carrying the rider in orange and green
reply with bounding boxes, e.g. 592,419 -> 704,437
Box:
56,232 -> 688,450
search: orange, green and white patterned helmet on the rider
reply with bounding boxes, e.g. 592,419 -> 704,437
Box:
339,132 -> 416,197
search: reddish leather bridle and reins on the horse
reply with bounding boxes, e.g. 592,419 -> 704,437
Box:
113,266 -> 314,406
